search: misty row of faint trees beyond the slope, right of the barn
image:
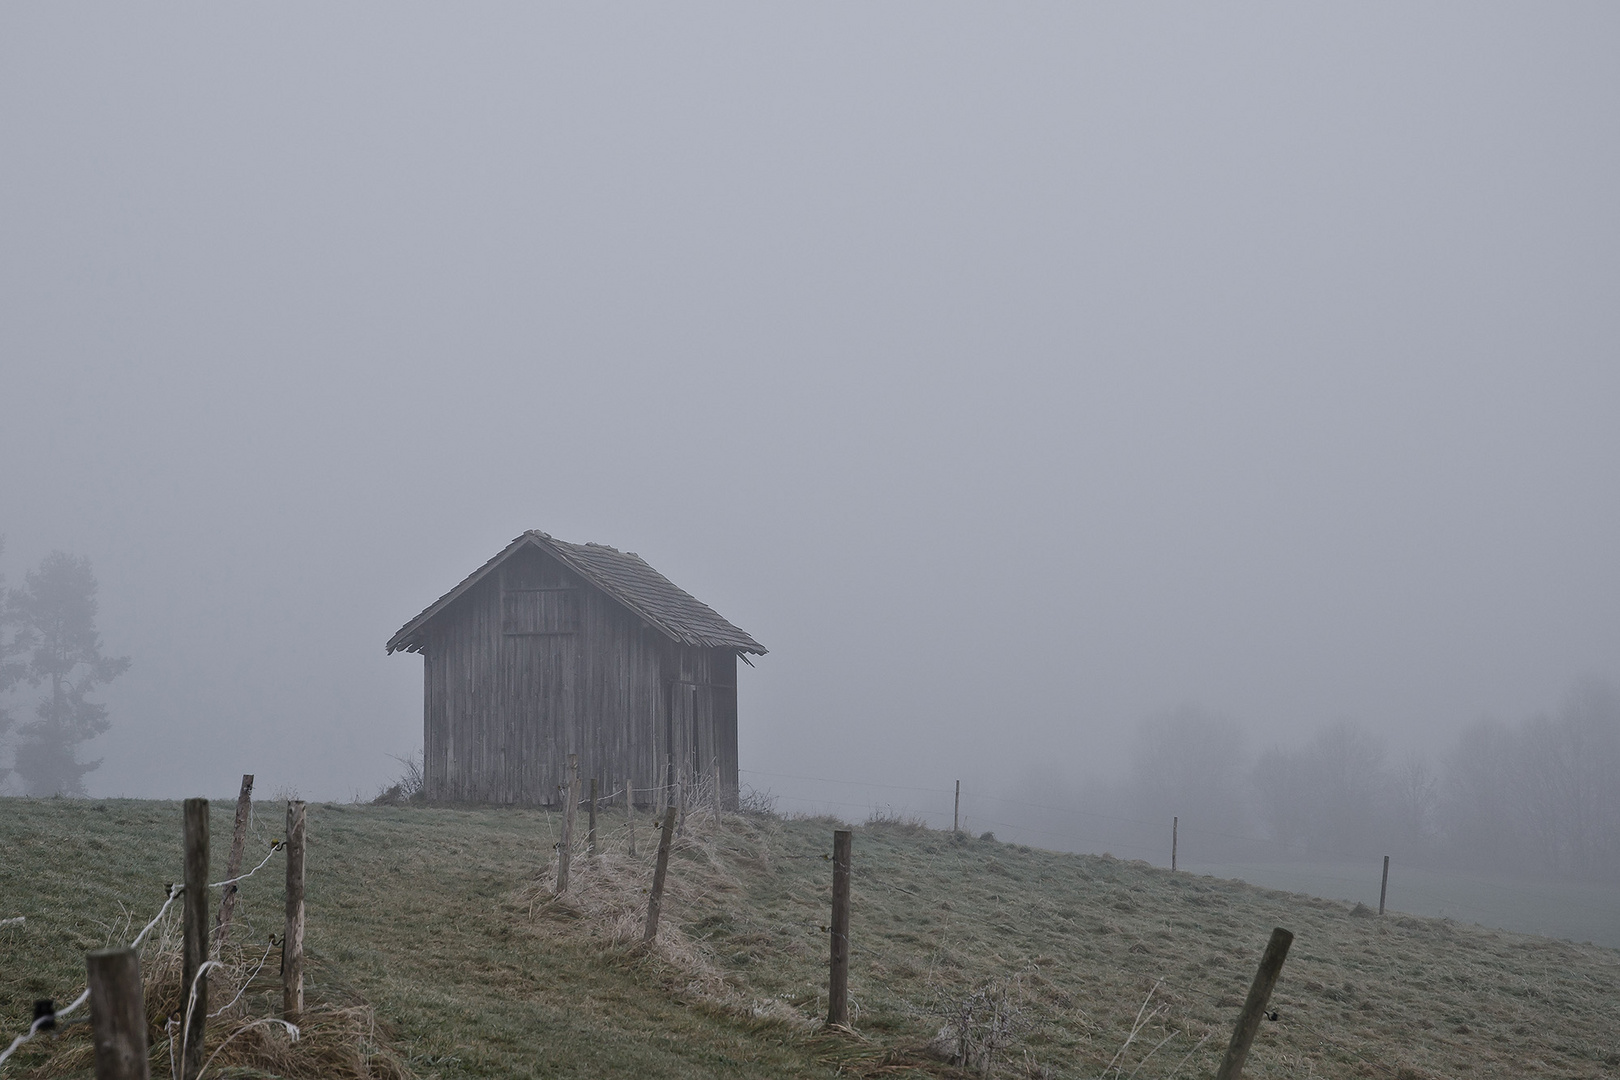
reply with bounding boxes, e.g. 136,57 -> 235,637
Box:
1128,682 -> 1620,879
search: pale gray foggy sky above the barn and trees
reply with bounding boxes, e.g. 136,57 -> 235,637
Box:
0,3 -> 1620,797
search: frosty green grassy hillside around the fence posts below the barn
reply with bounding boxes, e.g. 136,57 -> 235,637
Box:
0,800 -> 1620,1080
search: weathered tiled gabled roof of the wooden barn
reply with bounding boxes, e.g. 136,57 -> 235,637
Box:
387,529 -> 765,656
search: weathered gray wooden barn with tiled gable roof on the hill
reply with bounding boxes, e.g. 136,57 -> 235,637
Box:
387,531 -> 765,805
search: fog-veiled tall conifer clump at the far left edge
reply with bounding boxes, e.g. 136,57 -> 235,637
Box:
0,544 -> 130,795
